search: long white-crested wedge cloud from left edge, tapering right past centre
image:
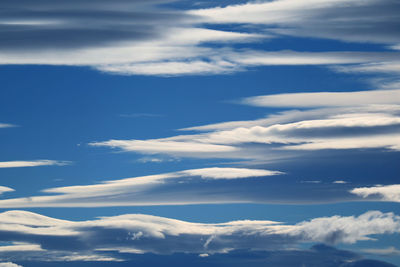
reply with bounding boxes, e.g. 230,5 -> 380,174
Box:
0,168 -> 283,209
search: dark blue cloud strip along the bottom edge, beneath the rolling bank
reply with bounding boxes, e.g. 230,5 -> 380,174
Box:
12,245 -> 395,267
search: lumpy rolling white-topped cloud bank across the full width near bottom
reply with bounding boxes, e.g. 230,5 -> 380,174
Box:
0,211 -> 400,260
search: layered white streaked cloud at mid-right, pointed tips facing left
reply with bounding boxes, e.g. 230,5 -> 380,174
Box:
90,90 -> 400,161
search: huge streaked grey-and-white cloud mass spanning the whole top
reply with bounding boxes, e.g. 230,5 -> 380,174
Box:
0,0 -> 400,76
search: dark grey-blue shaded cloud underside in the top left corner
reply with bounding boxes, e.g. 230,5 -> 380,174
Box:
0,0 -> 183,51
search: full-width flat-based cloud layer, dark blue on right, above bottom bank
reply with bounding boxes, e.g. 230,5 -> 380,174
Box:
0,164 -> 390,209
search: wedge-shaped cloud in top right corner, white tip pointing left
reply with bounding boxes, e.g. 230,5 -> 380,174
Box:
189,0 -> 399,44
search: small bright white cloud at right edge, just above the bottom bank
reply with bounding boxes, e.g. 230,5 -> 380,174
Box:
350,184 -> 400,202
